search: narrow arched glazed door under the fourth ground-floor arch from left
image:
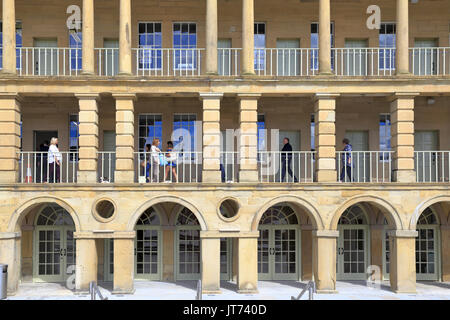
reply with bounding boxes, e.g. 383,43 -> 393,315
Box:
336,205 -> 369,280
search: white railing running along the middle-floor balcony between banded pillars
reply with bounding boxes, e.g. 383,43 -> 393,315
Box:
18,151 -> 450,184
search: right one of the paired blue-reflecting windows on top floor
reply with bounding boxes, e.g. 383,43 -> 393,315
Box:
173,23 -> 197,70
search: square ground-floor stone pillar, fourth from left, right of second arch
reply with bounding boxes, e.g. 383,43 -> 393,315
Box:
201,238 -> 221,294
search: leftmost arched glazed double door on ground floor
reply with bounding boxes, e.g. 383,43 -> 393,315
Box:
33,204 -> 76,282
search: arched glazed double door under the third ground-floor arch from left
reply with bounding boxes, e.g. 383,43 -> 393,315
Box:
258,204 -> 300,280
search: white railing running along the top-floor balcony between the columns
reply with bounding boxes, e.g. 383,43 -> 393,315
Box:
11,47 -> 450,78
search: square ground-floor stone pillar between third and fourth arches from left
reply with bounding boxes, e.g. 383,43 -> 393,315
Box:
313,230 -> 339,293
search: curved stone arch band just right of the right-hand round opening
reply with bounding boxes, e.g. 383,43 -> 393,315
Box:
251,195 -> 324,231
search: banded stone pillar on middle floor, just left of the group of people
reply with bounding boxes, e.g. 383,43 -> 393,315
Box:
113,94 -> 136,183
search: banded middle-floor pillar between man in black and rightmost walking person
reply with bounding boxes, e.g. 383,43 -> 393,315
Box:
314,94 -> 339,182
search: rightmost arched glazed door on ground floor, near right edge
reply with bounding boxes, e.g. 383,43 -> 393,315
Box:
416,207 -> 440,281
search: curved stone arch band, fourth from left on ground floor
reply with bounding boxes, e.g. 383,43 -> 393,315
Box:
330,196 -> 403,230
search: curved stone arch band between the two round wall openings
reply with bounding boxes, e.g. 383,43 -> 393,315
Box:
127,196 -> 208,231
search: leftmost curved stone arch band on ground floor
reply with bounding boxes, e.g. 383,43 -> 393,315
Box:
8,196 -> 81,232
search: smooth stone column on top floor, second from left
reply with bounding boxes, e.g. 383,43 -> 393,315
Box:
82,0 -> 95,75
